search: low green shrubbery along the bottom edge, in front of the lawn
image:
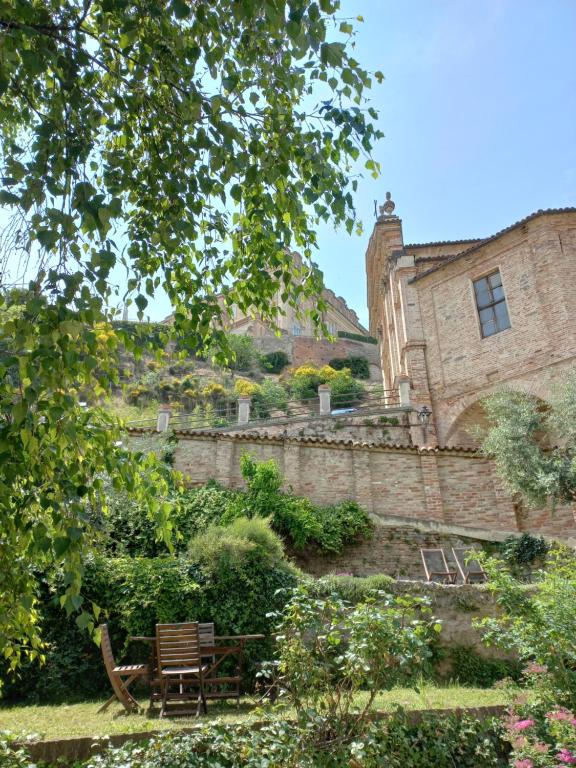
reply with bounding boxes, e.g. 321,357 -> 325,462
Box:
50,711 -> 508,768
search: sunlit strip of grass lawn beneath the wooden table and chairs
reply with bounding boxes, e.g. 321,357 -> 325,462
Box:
0,685 -> 518,739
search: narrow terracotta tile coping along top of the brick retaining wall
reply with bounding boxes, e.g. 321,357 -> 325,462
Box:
127,427 -> 477,453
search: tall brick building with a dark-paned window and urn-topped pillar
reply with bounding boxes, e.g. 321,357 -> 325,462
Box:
366,195 -> 576,448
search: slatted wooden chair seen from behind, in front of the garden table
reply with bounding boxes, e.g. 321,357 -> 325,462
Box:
156,621 -> 209,717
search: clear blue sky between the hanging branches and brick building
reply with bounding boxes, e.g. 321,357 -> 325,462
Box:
302,0 -> 576,323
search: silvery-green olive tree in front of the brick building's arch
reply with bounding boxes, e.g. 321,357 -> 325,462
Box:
482,372 -> 576,507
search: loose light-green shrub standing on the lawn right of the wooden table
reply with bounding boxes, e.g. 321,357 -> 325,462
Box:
268,585 -> 440,742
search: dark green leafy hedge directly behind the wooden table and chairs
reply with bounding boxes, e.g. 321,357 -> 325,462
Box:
4,548 -> 298,704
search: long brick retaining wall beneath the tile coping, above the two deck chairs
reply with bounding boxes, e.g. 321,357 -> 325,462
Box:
142,432 -> 576,538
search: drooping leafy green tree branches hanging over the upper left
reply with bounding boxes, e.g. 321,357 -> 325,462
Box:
0,0 -> 381,665
